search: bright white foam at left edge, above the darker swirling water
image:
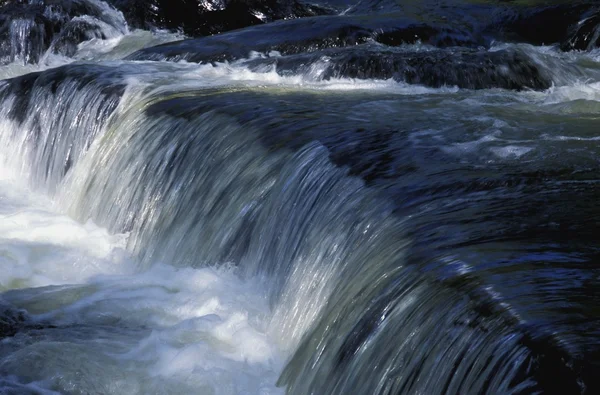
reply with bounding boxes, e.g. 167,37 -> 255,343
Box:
0,179 -> 129,290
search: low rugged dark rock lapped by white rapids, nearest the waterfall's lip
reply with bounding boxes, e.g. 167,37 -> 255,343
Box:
247,47 -> 552,90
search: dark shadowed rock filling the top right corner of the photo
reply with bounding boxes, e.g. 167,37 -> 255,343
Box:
348,0 -> 600,50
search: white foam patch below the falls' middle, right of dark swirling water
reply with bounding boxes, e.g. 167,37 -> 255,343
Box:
31,265 -> 282,393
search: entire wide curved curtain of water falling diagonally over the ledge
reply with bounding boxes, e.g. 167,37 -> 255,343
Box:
0,65 -> 592,394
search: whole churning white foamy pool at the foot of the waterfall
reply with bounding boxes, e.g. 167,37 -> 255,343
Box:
0,169 -> 285,395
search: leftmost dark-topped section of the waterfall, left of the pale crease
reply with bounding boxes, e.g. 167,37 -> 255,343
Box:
0,67 -> 123,193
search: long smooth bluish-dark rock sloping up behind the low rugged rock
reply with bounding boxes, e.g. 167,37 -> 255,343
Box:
129,16 -> 483,63
